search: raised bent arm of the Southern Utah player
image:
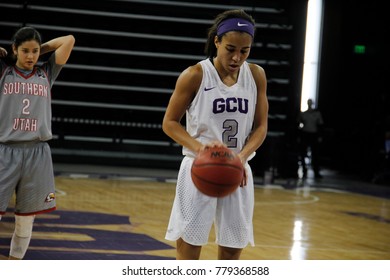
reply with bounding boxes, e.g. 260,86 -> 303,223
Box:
41,35 -> 75,65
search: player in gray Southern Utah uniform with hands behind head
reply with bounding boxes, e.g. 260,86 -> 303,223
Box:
0,27 -> 75,259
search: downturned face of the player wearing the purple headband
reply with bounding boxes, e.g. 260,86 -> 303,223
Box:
215,31 -> 252,73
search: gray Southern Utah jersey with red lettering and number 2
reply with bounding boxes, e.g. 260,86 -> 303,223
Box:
0,53 -> 62,143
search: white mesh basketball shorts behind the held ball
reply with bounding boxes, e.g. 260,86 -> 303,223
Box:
165,157 -> 254,248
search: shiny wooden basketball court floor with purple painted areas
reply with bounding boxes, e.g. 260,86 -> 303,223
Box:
0,166 -> 390,260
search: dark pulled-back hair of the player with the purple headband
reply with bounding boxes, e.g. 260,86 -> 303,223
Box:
204,10 -> 256,57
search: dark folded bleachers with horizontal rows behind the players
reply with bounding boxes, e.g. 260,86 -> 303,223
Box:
0,0 -> 301,174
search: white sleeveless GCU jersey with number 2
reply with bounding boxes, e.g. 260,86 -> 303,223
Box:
183,59 -> 257,157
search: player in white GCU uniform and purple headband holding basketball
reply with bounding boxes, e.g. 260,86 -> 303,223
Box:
163,10 -> 268,259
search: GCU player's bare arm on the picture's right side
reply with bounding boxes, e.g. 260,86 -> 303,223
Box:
239,64 -> 268,162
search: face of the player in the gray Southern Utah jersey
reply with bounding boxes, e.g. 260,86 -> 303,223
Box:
13,40 -> 41,70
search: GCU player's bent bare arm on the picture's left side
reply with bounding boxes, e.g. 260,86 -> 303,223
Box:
162,64 -> 203,152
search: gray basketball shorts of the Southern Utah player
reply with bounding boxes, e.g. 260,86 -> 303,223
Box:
0,142 -> 56,215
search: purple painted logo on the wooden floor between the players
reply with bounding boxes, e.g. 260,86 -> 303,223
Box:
0,209 -> 174,260
